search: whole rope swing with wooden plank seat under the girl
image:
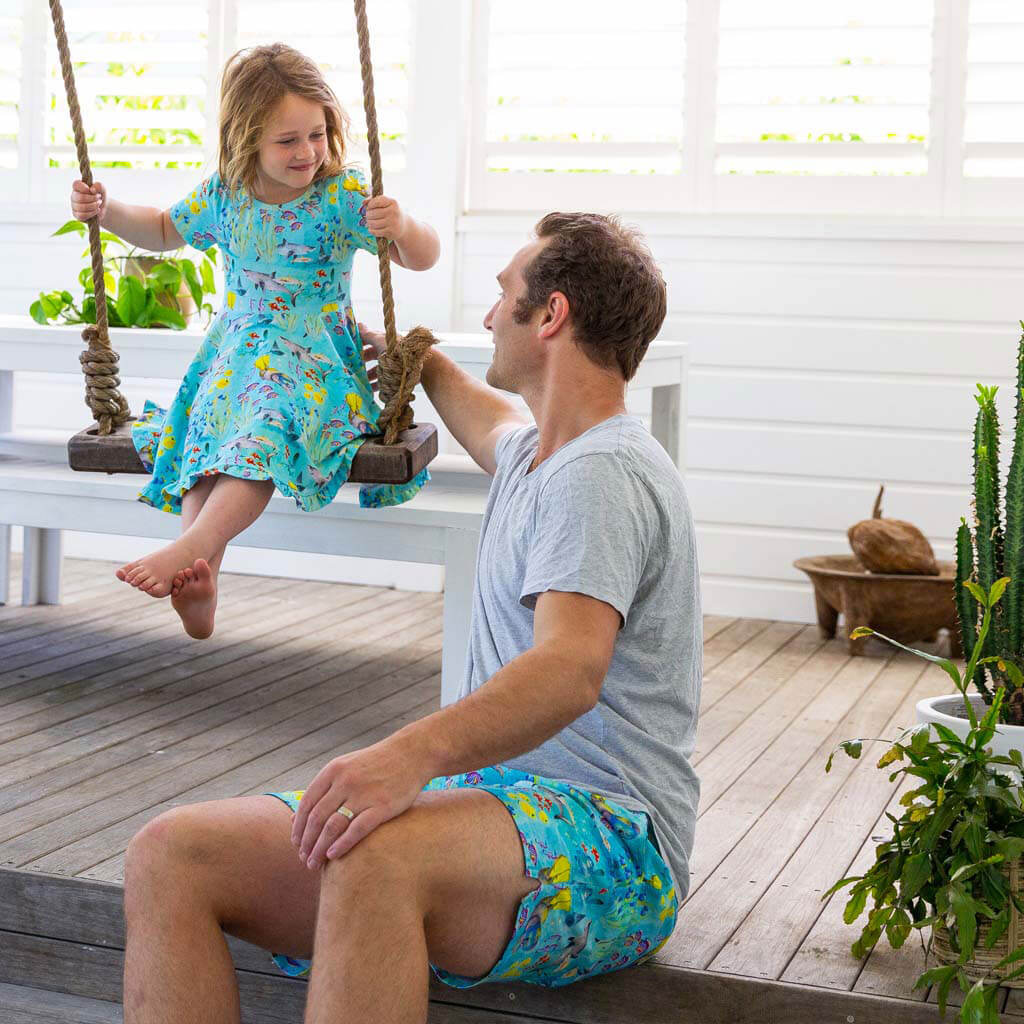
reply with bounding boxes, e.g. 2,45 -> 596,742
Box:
49,0 -> 437,483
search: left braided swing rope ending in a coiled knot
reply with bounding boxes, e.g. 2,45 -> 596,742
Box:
50,0 -> 131,434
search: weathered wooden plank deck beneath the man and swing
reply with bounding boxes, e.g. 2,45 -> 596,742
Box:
0,560 -> 1007,1024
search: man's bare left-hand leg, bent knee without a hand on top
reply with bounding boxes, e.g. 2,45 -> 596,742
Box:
124,797 -> 319,1024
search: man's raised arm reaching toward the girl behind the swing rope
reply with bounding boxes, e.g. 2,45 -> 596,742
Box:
359,324 -> 527,476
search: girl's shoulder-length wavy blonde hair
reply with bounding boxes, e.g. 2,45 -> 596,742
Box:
217,43 -> 349,195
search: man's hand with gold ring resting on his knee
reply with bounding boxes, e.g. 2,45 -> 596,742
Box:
292,733 -> 433,869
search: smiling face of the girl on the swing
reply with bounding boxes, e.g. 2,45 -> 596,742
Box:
259,93 -> 327,203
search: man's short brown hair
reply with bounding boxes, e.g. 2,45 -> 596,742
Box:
513,213 -> 666,381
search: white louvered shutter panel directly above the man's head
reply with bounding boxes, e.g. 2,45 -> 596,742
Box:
470,0 -> 686,208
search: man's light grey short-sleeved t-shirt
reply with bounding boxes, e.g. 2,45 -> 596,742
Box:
460,415 -> 702,900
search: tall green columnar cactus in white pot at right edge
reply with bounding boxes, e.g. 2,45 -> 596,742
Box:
955,322 -> 1024,725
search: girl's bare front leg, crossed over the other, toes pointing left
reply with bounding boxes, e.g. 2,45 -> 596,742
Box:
118,474 -> 273,597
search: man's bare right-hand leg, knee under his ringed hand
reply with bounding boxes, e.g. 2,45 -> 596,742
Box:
305,790 -> 539,1024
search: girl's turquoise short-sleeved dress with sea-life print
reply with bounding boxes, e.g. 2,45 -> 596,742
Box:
132,170 -> 429,514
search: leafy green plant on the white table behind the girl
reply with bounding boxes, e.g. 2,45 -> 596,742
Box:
29,220 -> 217,331
